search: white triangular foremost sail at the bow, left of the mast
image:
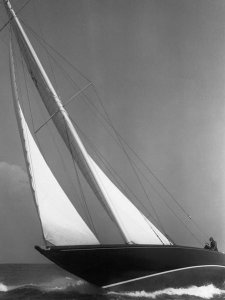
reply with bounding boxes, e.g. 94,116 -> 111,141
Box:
10,39 -> 99,245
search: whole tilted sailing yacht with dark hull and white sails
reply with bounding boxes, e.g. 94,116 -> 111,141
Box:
3,0 -> 225,291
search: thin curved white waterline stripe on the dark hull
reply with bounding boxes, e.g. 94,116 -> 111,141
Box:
102,265 -> 225,289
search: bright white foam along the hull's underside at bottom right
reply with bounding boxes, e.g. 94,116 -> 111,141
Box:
108,284 -> 225,299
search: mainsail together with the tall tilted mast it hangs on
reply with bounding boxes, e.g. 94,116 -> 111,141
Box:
5,0 -> 171,244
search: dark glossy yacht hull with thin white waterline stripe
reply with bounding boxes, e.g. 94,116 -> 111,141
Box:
36,245 -> 225,291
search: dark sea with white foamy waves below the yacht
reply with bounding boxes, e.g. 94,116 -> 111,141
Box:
0,264 -> 225,300
